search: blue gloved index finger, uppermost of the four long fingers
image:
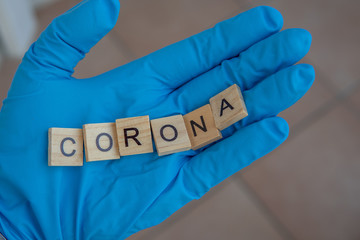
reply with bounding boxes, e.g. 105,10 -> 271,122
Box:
140,7 -> 283,89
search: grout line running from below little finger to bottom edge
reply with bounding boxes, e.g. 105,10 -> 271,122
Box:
233,173 -> 296,240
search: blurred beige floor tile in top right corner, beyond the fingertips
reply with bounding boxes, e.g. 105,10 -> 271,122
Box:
249,0 -> 360,92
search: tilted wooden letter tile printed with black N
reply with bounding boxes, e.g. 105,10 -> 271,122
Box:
184,104 -> 222,150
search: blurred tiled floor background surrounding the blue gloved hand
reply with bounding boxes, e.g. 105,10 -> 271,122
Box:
0,0 -> 360,240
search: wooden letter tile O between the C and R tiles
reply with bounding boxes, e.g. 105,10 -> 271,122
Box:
83,123 -> 120,162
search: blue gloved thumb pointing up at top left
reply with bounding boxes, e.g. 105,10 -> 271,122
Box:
22,0 -> 120,78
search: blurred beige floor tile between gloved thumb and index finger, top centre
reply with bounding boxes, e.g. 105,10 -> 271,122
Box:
116,0 -> 248,57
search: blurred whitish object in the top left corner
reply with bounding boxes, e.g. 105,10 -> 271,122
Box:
0,0 -> 37,58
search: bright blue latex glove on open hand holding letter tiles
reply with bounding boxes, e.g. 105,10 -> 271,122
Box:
0,0 -> 314,239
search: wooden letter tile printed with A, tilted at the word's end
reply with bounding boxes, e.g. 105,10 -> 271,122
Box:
210,84 -> 248,130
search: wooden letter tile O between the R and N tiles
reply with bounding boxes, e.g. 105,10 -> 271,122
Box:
151,115 -> 191,156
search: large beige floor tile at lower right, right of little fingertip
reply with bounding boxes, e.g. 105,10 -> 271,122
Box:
240,105 -> 360,240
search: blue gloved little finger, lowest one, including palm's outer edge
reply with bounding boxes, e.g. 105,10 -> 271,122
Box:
131,117 -> 289,232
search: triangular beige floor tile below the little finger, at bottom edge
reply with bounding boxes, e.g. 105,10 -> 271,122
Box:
129,178 -> 283,240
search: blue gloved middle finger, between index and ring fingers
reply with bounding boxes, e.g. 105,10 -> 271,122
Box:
171,29 -> 311,113
